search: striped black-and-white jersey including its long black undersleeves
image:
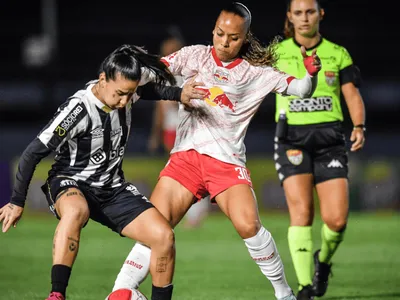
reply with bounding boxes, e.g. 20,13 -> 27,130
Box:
11,80 -> 181,206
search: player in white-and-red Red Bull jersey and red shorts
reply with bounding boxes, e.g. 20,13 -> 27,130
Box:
109,2 -> 321,299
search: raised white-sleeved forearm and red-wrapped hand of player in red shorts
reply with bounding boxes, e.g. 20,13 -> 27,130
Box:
287,46 -> 322,98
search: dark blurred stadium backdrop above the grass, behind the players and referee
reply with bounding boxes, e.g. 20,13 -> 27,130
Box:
0,0 -> 400,211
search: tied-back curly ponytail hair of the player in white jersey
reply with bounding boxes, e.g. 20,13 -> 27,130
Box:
222,2 -> 280,66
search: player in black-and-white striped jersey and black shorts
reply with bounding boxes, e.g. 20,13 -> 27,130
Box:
0,45 -> 206,300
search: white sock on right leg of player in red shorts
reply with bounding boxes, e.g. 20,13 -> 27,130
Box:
244,227 -> 292,299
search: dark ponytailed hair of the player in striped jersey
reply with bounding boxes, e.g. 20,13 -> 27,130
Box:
99,44 -> 176,85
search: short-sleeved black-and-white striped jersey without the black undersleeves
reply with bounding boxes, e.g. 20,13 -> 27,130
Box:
38,81 -> 132,188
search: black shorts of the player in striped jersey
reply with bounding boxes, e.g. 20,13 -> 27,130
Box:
42,176 -> 154,234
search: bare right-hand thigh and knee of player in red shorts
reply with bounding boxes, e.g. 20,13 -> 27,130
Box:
215,184 -> 261,238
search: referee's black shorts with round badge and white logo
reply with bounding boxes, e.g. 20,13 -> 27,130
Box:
274,122 -> 348,184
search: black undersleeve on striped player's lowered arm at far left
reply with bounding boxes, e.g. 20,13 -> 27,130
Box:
10,138 -> 51,207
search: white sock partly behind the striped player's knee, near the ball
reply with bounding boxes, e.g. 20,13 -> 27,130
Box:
113,243 -> 151,291
